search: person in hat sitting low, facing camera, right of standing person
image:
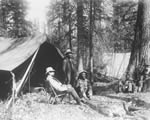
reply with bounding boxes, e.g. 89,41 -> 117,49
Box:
76,70 -> 90,100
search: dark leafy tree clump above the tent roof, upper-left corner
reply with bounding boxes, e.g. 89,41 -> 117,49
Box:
0,0 -> 31,37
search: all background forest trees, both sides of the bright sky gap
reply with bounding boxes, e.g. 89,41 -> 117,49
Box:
3,0 -> 149,90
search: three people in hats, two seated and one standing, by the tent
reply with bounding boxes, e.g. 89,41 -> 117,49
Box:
46,49 -> 90,104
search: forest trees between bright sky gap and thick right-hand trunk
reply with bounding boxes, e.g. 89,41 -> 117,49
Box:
48,0 -> 137,78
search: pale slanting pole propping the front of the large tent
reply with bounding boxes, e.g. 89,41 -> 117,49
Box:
6,48 -> 39,109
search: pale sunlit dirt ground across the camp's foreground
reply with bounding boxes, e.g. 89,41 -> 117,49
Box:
0,92 -> 150,120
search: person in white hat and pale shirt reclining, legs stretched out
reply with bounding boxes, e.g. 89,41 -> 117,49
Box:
46,67 -> 81,104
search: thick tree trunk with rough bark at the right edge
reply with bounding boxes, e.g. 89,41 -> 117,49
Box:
127,0 -> 150,90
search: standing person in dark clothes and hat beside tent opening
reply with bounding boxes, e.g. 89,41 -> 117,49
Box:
63,49 -> 76,87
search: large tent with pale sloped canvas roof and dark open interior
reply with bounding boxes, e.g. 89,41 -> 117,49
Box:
0,34 -> 64,98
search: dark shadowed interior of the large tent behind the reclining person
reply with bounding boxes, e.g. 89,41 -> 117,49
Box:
0,42 -> 64,99
